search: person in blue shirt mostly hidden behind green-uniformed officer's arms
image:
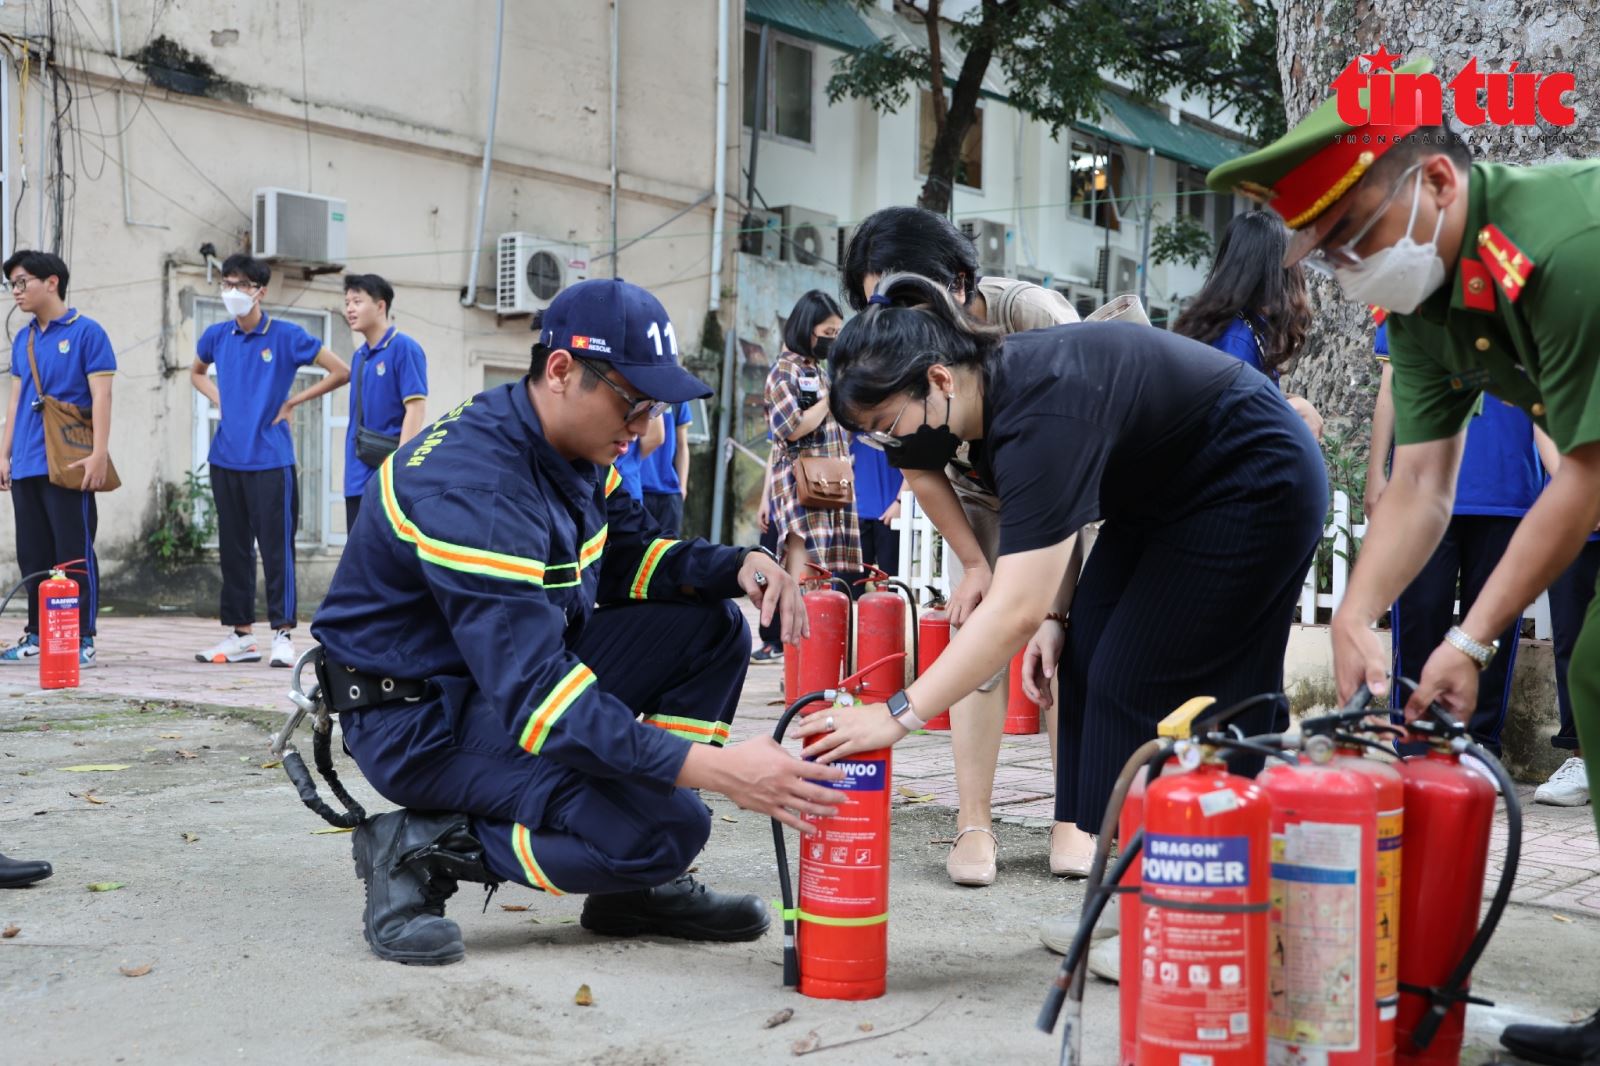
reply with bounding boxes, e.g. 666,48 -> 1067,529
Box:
1366,325 -> 1544,754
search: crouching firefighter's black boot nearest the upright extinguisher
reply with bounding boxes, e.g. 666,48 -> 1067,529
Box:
579,874 -> 770,941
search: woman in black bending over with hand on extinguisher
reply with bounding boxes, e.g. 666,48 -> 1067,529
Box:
797,274 -> 1328,832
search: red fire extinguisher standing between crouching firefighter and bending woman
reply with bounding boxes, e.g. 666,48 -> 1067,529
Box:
773,651 -> 906,999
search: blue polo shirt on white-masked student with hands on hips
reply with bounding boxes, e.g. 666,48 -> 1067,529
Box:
195,312 -> 322,471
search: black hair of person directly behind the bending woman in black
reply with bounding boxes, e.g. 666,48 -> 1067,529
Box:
842,206 -> 978,311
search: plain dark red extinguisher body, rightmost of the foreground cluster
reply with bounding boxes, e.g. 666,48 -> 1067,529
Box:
1395,751 -> 1494,1066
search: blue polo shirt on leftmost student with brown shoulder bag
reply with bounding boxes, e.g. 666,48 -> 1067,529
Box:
11,307 -> 117,477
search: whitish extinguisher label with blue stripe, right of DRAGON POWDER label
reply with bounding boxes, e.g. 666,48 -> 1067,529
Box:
1267,821 -> 1363,1061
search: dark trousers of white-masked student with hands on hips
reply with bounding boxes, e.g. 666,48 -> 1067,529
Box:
211,466 -> 299,629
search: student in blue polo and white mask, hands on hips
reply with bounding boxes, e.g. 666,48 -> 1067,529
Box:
189,254 -> 350,666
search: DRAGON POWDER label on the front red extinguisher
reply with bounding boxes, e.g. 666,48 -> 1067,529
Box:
1145,834 -> 1261,1063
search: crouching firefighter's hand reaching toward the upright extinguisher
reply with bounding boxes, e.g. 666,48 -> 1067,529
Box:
697,736 -> 846,832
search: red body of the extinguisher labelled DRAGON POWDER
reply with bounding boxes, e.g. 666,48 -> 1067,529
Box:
1122,763 -> 1272,1066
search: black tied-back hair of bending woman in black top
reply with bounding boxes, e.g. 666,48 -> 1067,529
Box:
829,274 -> 1005,431
